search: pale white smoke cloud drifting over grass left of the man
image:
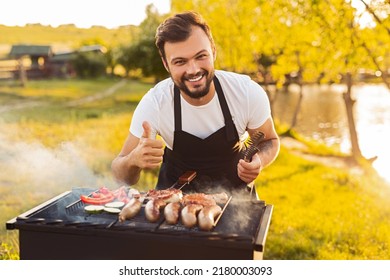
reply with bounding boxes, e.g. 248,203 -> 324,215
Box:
0,129 -> 113,197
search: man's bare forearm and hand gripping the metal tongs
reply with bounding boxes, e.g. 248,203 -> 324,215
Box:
237,118 -> 280,183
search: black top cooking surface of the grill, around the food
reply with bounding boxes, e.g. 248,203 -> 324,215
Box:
9,188 -> 261,240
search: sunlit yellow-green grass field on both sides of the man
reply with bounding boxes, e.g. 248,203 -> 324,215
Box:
0,79 -> 390,260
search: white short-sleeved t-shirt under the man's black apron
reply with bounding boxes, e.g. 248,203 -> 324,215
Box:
130,70 -> 271,149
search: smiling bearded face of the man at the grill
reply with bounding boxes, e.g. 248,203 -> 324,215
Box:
164,27 -> 215,99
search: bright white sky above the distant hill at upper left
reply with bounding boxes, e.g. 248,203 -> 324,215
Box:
0,0 -> 170,28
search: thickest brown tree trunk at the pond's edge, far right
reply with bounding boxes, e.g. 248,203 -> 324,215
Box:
343,73 -> 362,160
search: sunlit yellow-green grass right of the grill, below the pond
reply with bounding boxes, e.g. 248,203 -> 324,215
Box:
257,149 -> 390,260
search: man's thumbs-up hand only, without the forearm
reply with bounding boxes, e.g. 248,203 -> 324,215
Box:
131,121 -> 164,169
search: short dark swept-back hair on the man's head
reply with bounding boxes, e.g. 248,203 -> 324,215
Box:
156,11 -> 215,60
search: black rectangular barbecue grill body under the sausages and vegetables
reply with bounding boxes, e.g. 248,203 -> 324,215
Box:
6,183 -> 273,260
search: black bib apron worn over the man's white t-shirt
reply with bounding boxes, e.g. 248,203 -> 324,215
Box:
156,76 -> 246,192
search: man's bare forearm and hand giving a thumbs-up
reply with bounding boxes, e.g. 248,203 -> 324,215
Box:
111,122 -> 164,185
